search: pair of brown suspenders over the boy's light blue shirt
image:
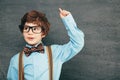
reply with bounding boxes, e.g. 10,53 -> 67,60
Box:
18,46 -> 53,80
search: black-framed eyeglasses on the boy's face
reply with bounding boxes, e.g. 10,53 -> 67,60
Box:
23,25 -> 42,34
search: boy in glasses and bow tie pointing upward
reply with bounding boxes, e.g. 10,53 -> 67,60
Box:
7,8 -> 84,80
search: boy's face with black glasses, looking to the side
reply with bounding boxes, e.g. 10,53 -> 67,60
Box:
23,22 -> 45,45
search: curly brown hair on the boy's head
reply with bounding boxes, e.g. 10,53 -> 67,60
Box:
19,10 -> 50,35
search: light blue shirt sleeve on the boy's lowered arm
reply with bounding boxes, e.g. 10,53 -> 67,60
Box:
7,57 -> 18,80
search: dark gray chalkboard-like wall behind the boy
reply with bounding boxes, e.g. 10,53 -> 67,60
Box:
0,0 -> 120,80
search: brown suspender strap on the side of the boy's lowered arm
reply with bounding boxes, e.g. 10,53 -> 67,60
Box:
18,51 -> 24,80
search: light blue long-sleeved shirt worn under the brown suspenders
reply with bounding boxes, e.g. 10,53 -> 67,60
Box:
7,14 -> 84,80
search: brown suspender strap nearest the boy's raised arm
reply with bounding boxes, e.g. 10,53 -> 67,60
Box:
46,46 -> 53,80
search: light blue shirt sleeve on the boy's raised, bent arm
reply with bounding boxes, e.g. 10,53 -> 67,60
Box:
52,14 -> 84,62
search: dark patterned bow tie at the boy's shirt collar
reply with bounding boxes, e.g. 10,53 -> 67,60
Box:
23,43 -> 44,56
